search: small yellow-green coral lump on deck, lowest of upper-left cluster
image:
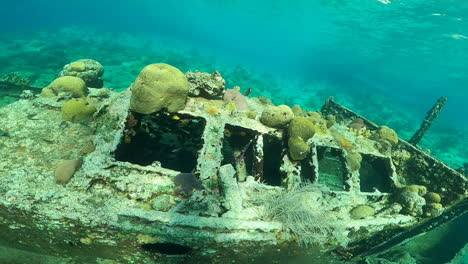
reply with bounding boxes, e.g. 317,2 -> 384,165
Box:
62,98 -> 96,121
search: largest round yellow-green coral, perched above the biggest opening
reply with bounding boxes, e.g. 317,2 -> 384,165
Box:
130,63 -> 189,114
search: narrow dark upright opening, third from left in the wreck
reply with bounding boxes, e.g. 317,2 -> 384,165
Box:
262,135 -> 284,186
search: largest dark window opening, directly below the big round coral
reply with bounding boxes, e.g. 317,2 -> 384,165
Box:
115,112 -> 206,172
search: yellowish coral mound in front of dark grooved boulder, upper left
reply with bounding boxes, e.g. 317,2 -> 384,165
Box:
41,76 -> 88,98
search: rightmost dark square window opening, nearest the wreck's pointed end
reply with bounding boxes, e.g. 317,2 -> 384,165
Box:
359,154 -> 391,192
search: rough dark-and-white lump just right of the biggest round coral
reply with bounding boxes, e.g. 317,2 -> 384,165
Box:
185,71 -> 226,99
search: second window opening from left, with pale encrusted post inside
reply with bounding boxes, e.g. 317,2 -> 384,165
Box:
221,124 -> 257,181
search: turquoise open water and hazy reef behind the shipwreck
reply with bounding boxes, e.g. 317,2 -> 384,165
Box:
0,0 -> 468,262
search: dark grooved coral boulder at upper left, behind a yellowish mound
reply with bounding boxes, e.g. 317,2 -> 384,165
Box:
59,59 -> 104,88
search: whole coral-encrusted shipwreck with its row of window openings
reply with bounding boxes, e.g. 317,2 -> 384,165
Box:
0,60 -> 468,263
